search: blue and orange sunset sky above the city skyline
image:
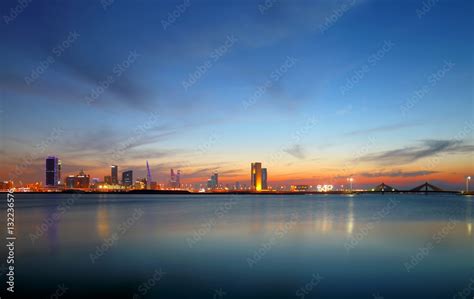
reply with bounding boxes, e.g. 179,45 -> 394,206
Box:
0,0 -> 474,188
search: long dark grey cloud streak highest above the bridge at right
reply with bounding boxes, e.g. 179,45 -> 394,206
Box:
360,140 -> 474,165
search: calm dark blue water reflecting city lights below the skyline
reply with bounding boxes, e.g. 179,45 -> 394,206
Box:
0,194 -> 474,299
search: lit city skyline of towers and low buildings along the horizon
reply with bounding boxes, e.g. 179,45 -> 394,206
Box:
0,156 -> 471,192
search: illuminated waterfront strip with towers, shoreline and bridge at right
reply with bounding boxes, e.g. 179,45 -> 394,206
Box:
0,156 -> 471,194
